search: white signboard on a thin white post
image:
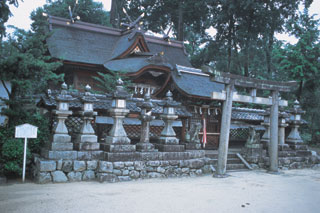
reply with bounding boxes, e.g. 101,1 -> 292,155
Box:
15,124 -> 38,182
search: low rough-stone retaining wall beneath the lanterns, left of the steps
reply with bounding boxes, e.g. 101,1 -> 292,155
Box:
33,157 -> 213,183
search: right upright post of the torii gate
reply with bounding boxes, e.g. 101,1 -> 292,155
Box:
269,90 -> 279,173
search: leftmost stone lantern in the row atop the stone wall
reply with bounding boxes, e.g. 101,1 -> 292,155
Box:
50,83 -> 74,151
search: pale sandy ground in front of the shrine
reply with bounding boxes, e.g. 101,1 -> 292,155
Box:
0,169 -> 320,213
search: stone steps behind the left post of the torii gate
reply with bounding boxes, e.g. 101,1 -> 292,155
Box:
205,150 -> 248,171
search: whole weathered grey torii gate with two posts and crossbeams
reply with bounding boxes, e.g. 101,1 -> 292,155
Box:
206,67 -> 297,177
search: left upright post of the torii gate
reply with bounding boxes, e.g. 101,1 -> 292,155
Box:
216,83 -> 234,177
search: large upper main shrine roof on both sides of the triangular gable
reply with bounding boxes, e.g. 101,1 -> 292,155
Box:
47,16 -> 191,66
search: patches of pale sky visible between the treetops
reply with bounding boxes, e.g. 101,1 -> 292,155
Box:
7,0 -> 320,43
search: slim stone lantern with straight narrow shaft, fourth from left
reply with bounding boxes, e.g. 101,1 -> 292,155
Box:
136,93 -> 155,152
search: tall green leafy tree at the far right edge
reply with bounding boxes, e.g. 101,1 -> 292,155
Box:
276,9 -> 320,141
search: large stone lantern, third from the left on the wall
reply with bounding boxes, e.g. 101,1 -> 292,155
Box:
101,79 -> 136,152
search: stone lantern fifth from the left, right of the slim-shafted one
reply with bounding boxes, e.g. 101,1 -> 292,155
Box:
156,90 -> 184,152
